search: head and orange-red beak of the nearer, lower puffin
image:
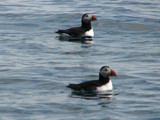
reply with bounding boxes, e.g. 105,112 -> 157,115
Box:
99,66 -> 117,78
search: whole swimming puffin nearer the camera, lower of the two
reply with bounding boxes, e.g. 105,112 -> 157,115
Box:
67,66 -> 117,92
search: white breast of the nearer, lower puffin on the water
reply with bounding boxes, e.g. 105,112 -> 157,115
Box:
97,80 -> 113,91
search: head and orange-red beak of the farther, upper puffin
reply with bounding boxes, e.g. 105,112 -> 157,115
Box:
82,13 -> 97,23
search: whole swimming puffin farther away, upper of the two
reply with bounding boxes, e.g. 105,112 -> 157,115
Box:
56,13 -> 97,37
